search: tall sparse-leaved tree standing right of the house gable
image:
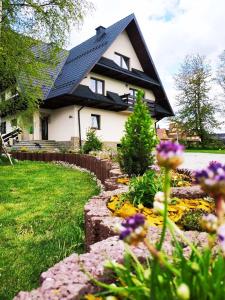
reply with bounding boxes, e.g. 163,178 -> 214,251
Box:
175,55 -> 219,146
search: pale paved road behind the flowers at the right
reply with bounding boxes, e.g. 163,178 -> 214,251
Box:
181,153 -> 225,170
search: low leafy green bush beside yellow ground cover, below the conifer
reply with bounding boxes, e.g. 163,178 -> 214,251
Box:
125,170 -> 162,207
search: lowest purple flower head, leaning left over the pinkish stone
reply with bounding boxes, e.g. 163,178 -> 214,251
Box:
119,214 -> 147,245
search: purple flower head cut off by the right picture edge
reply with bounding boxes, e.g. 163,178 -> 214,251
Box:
195,161 -> 225,196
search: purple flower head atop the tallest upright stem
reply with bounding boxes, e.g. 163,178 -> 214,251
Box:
156,141 -> 184,169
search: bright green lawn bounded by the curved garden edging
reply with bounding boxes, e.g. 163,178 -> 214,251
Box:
0,162 -> 99,300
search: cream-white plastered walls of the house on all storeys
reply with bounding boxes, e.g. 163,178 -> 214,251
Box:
0,31 -> 155,145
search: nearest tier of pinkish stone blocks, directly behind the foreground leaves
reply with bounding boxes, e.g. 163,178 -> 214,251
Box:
14,227 -> 207,300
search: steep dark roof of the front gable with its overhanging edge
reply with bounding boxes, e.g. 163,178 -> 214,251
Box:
46,14 -> 173,115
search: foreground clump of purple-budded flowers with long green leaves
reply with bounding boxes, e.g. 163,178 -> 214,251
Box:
87,142 -> 225,300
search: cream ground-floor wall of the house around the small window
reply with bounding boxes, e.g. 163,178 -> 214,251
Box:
43,105 -> 130,142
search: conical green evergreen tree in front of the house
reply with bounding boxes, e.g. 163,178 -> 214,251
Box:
118,91 -> 157,176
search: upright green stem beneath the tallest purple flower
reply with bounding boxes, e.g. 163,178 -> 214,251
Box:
157,168 -> 170,251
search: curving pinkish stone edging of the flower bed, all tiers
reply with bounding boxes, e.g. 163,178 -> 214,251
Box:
12,151 -> 218,300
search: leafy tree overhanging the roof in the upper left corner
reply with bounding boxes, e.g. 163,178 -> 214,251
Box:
0,0 -> 91,112
